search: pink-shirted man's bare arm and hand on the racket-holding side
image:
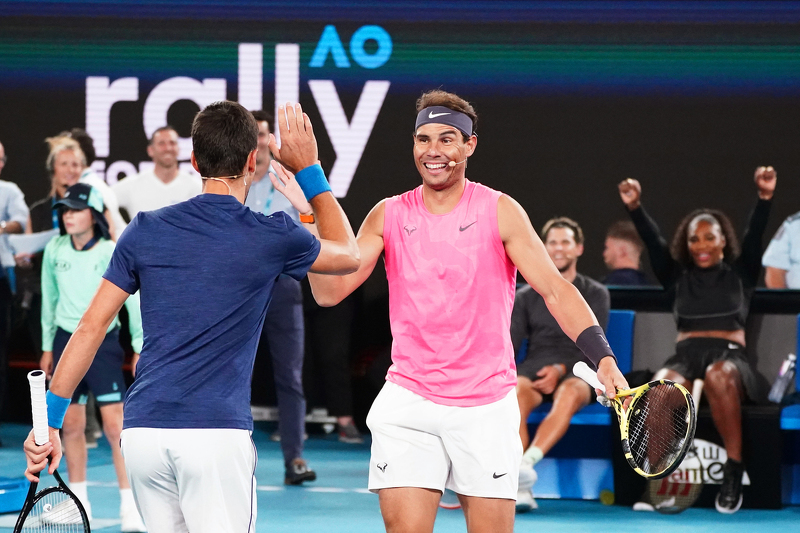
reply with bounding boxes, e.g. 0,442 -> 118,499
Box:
497,195 -> 628,392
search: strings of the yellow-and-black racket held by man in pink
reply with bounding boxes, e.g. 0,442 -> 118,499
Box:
628,383 -> 691,474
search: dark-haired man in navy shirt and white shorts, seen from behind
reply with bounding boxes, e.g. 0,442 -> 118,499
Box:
25,102 -> 360,533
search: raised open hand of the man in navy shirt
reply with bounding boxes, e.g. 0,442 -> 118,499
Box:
269,103 -> 319,174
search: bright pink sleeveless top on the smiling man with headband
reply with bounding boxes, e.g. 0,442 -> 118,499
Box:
383,181 -> 517,407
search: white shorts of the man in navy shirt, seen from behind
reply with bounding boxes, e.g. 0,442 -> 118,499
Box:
120,428 -> 257,533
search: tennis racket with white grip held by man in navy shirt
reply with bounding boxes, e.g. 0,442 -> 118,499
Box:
14,370 -> 91,533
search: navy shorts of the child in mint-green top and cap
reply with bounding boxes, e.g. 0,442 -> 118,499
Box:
53,327 -> 125,406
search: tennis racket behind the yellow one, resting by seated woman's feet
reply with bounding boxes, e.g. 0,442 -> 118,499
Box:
649,379 -> 704,514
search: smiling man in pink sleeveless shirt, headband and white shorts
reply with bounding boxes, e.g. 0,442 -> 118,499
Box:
279,91 -> 627,533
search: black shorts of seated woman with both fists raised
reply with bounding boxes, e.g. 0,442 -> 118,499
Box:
664,337 -> 759,400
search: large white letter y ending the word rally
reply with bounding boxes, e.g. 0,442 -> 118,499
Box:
308,80 -> 389,198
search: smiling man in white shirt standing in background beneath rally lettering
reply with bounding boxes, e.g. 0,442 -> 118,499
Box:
112,126 -> 202,219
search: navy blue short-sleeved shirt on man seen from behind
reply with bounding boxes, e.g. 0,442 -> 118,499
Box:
103,194 -> 320,430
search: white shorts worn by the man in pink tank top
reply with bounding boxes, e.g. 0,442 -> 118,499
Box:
367,382 -> 522,500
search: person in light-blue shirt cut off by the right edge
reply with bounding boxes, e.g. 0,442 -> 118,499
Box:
761,213 -> 800,289
